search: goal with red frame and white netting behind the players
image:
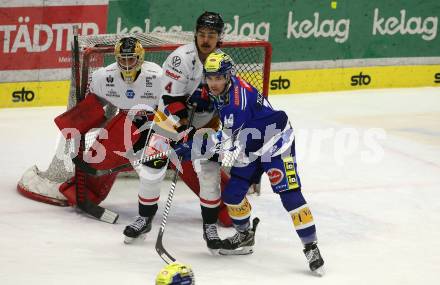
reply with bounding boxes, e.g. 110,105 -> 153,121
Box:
18,32 -> 272,195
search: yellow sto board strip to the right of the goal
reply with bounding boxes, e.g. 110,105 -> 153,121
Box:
269,65 -> 440,95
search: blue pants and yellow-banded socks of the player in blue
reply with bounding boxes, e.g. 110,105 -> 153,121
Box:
222,135 -> 316,244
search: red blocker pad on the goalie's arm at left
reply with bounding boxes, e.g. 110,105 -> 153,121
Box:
54,94 -> 105,139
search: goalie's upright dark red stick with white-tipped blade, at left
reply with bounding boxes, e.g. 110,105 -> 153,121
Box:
73,26 -> 119,224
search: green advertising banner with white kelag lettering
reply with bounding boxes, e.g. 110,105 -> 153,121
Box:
108,0 -> 440,64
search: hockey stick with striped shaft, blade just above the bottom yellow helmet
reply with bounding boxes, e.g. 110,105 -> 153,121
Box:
156,104 -> 196,264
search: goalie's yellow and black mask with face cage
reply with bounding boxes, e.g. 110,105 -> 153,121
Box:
115,37 -> 145,83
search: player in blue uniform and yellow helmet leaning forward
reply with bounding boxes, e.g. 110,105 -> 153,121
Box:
201,52 -> 324,275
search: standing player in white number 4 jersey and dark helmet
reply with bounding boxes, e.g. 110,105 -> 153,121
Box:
127,12 -> 231,253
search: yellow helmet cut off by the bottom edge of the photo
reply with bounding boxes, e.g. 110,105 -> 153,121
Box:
156,263 -> 195,285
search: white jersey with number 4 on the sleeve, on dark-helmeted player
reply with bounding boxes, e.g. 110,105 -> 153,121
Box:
159,42 -> 215,128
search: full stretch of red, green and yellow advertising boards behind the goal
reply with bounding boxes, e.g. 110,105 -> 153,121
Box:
0,0 -> 440,108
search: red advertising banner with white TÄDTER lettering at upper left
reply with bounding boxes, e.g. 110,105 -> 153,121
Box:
0,5 -> 107,70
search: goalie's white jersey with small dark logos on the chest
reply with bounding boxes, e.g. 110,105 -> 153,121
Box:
89,62 -> 163,110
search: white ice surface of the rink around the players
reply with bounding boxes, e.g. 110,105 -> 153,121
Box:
0,88 -> 440,285
